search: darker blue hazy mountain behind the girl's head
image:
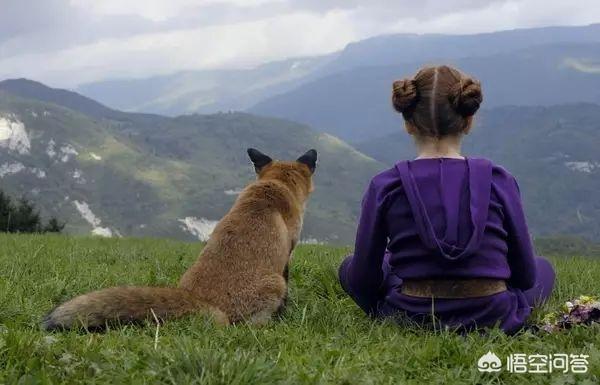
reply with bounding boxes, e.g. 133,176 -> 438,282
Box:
249,43 -> 600,143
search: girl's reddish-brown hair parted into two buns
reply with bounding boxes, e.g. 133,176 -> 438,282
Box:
392,65 -> 483,137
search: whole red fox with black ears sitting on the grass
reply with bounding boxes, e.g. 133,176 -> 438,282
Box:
42,148 -> 317,330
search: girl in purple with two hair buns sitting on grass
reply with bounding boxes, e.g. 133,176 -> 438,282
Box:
339,66 -> 555,333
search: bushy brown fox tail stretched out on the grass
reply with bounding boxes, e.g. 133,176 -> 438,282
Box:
41,286 -> 229,331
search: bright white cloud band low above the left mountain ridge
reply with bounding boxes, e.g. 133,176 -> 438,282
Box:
0,11 -> 359,86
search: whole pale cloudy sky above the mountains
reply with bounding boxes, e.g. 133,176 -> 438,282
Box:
0,0 -> 600,88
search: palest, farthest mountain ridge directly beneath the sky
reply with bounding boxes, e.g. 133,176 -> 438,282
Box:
77,24 -> 600,120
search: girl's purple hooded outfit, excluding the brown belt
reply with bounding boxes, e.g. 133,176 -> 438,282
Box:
339,158 -> 554,333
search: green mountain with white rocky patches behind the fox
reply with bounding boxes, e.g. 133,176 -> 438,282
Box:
0,80 -> 383,243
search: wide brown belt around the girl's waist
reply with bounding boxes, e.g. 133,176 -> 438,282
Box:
400,278 -> 506,299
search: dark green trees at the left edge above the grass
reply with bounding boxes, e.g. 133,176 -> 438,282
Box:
0,191 -> 65,233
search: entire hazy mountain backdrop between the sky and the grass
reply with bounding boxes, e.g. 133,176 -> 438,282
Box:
0,24 -> 600,243
